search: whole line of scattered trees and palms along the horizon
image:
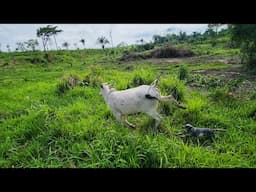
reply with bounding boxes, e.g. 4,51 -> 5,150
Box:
0,24 -> 256,68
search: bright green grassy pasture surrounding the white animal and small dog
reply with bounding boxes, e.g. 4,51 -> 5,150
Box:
0,41 -> 256,168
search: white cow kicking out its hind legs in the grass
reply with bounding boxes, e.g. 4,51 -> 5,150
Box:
100,79 -> 186,128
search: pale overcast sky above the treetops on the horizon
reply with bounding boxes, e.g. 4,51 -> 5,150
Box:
0,24 -> 210,51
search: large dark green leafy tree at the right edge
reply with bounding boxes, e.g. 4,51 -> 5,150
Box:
231,24 -> 256,68
